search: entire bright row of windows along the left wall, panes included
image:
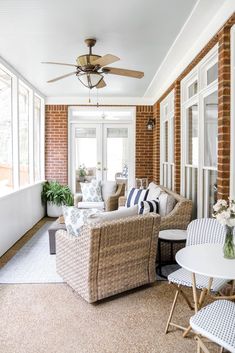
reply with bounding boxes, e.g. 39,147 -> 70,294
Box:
0,63 -> 44,197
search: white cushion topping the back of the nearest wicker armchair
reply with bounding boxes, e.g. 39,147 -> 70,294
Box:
87,205 -> 138,224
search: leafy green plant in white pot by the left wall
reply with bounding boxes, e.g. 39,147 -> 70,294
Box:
41,181 -> 73,217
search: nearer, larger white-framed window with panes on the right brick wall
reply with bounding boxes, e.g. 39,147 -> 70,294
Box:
181,46 -> 218,217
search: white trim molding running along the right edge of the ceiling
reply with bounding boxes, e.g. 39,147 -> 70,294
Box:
144,0 -> 235,104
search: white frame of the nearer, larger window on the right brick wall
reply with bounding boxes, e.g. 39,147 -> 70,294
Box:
181,45 -> 218,218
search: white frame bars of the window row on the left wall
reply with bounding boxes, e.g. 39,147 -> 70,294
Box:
0,57 -> 45,198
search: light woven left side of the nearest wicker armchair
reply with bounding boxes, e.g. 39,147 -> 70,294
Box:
56,226 -> 100,303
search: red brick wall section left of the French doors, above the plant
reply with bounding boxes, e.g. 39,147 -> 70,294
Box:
45,105 -> 68,184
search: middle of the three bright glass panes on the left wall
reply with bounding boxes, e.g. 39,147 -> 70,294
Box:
19,84 -> 29,186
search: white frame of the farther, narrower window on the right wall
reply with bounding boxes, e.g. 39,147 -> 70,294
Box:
160,90 -> 175,190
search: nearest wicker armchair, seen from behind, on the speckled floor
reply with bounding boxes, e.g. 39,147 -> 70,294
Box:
56,214 -> 160,303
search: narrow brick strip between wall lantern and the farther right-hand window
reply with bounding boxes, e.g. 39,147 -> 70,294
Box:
153,102 -> 160,184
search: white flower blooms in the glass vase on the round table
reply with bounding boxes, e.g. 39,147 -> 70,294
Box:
212,199 -> 235,227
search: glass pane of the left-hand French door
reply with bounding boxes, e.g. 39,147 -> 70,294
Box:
75,127 -> 97,192
